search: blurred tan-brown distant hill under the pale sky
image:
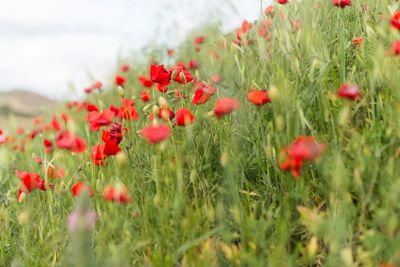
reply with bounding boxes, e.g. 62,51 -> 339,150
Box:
0,90 -> 56,117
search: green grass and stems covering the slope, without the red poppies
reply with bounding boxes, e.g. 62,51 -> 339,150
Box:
0,0 -> 400,266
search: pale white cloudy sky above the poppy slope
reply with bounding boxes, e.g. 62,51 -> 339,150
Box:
0,0 -> 270,99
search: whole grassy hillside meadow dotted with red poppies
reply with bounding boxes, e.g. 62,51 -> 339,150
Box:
0,0 -> 400,266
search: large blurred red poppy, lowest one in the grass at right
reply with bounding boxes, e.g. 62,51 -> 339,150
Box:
279,136 -> 324,177
